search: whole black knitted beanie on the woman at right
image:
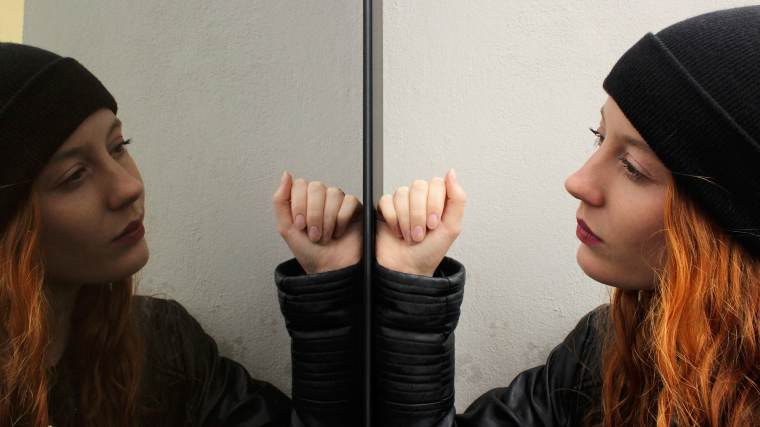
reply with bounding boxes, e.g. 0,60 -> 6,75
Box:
604,6 -> 760,256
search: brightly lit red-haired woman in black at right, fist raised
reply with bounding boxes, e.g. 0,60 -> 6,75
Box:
375,6 -> 760,427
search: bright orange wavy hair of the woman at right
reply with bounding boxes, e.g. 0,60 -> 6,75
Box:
601,181 -> 760,427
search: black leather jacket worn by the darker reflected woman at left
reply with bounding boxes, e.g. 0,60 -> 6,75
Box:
48,259 -> 360,427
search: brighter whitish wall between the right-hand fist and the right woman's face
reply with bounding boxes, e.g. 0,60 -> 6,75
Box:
383,0 -> 753,410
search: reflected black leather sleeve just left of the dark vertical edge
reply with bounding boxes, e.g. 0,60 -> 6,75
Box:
275,258 -> 361,427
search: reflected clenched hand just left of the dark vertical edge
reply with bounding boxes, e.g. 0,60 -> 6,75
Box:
272,172 -> 362,274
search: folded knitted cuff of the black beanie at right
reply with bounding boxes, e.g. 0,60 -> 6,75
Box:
603,33 -> 760,254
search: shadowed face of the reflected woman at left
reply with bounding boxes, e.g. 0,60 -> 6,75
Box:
34,109 -> 148,285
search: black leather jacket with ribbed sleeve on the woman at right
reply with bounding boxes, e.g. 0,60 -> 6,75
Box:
373,257 -> 607,427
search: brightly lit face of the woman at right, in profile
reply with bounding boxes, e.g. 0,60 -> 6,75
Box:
565,97 -> 671,289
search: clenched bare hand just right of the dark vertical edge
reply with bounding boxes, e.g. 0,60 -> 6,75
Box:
375,170 -> 467,276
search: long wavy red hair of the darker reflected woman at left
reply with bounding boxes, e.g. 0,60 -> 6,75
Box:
0,194 -> 142,427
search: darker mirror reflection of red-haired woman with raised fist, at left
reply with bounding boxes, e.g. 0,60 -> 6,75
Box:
0,43 -> 361,427
